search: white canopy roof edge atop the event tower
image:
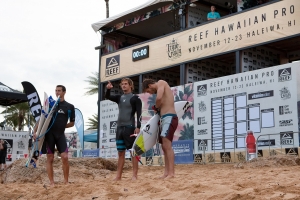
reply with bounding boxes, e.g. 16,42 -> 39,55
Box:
92,0 -> 173,32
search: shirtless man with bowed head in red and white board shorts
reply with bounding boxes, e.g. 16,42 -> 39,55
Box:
143,79 -> 178,179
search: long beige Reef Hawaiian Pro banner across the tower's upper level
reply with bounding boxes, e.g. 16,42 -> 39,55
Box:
100,0 -> 300,82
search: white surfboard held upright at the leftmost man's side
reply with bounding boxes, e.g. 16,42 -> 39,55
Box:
26,97 -> 60,167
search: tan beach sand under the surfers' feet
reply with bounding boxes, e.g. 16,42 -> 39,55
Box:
0,156 -> 300,200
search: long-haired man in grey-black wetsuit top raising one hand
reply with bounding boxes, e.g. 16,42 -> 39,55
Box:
105,78 -> 142,181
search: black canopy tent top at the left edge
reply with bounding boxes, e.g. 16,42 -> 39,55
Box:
0,82 -> 28,106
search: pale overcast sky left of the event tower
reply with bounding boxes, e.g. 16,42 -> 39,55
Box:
0,0 -> 148,132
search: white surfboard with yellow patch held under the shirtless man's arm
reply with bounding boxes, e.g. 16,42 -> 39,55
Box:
131,101 -> 193,157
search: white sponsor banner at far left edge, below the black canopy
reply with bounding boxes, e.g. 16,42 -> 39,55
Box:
0,130 -> 29,164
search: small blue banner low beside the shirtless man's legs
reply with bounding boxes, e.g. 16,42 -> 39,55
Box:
172,140 -> 194,164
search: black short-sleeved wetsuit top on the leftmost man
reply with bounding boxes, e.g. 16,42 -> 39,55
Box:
49,101 -> 75,133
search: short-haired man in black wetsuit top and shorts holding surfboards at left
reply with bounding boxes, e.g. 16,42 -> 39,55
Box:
33,85 -> 75,186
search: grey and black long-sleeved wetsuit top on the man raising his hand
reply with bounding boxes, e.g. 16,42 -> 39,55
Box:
105,90 -> 142,128
